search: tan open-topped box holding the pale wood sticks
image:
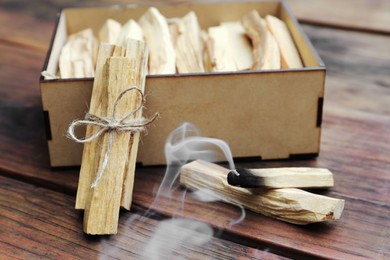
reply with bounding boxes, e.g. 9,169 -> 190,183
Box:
40,1 -> 325,167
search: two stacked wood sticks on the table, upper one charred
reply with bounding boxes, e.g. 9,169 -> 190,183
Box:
180,160 -> 345,225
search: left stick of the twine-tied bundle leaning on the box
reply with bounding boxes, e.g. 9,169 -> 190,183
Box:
75,44 -> 118,209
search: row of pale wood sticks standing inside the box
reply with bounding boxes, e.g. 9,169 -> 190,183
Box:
58,7 -> 303,78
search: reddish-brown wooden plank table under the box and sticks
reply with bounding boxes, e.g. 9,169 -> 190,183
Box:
0,0 -> 390,259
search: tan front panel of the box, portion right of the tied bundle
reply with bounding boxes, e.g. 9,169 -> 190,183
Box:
138,70 -> 324,165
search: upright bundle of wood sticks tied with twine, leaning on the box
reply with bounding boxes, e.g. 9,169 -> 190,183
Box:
68,39 -> 148,234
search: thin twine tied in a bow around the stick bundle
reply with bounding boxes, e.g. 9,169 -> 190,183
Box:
68,87 -> 159,188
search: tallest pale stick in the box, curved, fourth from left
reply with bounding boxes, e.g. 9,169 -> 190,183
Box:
139,7 -> 176,74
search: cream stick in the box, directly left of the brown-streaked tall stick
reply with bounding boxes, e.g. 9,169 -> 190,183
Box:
221,22 -> 253,70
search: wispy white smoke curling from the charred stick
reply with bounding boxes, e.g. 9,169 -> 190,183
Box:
108,123 -> 245,260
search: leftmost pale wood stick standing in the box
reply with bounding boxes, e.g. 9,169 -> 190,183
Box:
59,29 -> 97,79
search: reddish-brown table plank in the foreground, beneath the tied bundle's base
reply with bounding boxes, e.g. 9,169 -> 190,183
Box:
0,177 -> 283,259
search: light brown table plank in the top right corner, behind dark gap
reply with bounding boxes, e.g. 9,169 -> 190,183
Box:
287,0 -> 390,34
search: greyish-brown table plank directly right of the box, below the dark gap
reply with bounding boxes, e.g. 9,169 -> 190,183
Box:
303,26 -> 390,115
